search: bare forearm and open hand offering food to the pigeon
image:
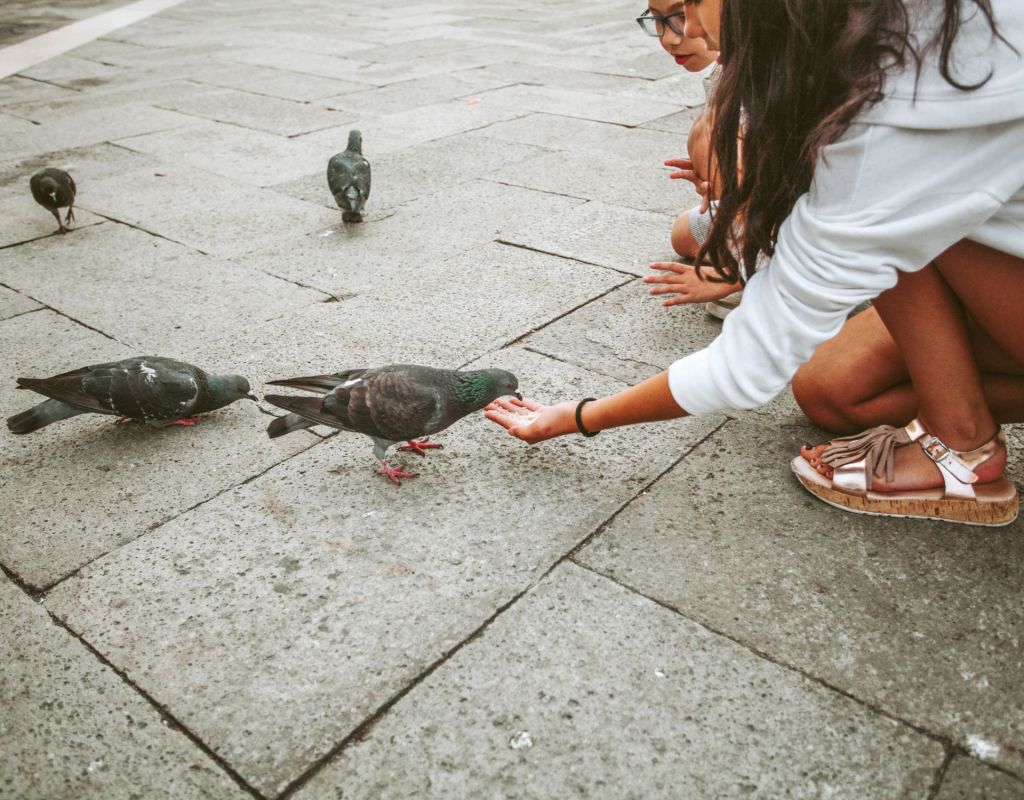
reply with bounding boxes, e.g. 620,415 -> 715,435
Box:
484,372 -> 686,445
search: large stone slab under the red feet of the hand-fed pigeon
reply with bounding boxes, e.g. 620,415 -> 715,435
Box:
46,351 -> 712,795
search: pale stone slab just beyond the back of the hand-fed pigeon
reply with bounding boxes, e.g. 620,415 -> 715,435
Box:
192,244 -> 622,393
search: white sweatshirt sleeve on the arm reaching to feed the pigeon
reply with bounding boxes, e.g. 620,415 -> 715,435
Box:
669,120 -> 1024,414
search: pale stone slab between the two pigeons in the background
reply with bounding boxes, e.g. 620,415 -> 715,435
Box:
83,162 -> 337,257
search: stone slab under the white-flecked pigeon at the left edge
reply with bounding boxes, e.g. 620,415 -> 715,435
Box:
0,310 -> 317,588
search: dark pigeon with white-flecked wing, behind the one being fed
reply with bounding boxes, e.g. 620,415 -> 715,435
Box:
7,355 -> 256,434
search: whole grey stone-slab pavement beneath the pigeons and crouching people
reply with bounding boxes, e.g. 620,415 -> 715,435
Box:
0,0 -> 1024,800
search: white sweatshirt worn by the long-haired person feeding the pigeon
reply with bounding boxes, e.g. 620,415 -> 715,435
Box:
669,0 -> 1024,414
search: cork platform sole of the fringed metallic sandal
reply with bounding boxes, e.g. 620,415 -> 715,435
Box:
792,456 -> 1020,528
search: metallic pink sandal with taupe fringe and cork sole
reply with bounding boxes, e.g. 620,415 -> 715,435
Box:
793,420 -> 1019,525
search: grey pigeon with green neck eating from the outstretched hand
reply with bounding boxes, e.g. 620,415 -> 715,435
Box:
264,364 -> 521,485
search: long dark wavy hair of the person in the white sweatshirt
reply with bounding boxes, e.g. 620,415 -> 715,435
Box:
696,0 -> 1011,283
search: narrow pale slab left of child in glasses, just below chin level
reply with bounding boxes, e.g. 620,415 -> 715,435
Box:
482,85 -> 682,125
